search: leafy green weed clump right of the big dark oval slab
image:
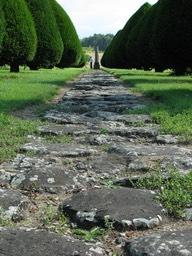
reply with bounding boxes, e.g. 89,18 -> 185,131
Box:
136,169 -> 192,218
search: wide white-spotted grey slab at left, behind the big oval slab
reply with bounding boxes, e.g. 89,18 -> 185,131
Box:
0,155 -> 96,193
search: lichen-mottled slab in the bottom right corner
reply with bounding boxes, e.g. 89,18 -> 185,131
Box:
124,230 -> 192,256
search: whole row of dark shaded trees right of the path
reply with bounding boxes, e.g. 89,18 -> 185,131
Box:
101,0 -> 192,75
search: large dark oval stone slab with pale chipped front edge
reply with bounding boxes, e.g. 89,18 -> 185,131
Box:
62,188 -> 163,230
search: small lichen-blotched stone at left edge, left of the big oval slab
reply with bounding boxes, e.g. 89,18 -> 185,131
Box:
0,189 -> 30,221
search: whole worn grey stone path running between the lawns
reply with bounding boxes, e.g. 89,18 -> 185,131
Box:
0,70 -> 192,256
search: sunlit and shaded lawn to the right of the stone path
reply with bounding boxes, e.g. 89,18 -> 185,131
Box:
106,69 -> 192,143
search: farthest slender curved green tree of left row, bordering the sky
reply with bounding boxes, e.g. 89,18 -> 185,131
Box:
50,0 -> 85,68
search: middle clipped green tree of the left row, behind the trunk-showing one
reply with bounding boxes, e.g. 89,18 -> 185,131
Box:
26,0 -> 63,70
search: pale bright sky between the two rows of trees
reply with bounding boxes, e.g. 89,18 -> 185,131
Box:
56,0 -> 158,39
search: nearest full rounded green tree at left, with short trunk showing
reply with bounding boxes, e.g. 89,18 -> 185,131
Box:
0,0 -> 37,72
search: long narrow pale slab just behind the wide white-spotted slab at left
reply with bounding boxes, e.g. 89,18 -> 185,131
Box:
20,139 -> 98,157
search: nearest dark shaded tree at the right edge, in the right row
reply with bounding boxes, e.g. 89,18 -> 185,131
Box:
154,0 -> 192,75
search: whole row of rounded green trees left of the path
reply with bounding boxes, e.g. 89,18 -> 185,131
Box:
0,0 -> 85,72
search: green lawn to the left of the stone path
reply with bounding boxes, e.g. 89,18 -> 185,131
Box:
0,68 -> 86,162
